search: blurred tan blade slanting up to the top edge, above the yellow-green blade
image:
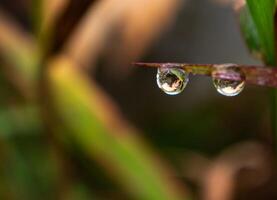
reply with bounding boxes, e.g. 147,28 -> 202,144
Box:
63,0 -> 126,67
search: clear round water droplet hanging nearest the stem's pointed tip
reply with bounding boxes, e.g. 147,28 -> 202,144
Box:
157,68 -> 189,95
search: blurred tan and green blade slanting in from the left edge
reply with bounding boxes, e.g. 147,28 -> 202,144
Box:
0,10 -> 39,98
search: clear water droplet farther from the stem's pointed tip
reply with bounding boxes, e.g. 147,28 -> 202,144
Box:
213,65 -> 245,97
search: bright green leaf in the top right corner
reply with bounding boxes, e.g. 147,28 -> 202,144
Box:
240,0 -> 276,66
